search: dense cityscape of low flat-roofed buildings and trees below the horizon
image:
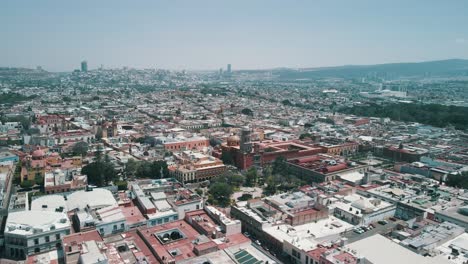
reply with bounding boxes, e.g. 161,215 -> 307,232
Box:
0,58 -> 468,264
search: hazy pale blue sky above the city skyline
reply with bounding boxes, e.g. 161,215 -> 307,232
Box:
0,0 -> 468,71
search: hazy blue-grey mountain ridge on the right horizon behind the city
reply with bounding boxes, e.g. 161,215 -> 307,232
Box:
239,59 -> 468,79
